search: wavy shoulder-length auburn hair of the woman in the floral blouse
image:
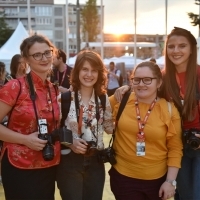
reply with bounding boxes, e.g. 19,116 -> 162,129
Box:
70,50 -> 107,96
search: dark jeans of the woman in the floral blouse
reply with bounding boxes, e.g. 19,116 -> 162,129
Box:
56,151 -> 105,200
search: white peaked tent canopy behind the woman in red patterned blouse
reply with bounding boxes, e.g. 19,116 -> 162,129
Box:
0,22 -> 29,71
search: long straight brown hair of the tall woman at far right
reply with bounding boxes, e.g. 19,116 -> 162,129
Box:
163,27 -> 197,121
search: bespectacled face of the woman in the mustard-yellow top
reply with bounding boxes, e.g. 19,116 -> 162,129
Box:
132,66 -> 162,104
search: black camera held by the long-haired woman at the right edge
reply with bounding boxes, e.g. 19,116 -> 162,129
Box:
183,128 -> 200,149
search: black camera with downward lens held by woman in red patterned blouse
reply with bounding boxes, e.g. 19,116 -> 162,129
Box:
38,119 -> 72,161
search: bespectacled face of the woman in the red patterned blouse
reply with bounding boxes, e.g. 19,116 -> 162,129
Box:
26,42 -> 53,75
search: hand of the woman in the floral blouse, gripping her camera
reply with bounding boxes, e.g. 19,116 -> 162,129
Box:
69,139 -> 88,154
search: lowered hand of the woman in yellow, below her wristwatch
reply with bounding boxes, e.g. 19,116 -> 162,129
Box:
159,182 -> 175,200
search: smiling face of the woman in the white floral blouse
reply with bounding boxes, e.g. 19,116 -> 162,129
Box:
79,61 -> 98,89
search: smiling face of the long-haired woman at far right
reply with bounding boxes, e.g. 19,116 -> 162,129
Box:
167,35 -> 192,72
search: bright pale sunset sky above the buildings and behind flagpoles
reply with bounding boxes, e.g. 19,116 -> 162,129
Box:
55,0 -> 200,38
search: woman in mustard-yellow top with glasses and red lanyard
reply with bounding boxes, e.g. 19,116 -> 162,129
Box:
109,61 -> 182,200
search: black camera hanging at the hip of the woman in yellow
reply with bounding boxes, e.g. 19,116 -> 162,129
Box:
99,147 -> 117,165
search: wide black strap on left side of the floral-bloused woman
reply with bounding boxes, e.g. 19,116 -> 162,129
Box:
60,91 -> 71,127
